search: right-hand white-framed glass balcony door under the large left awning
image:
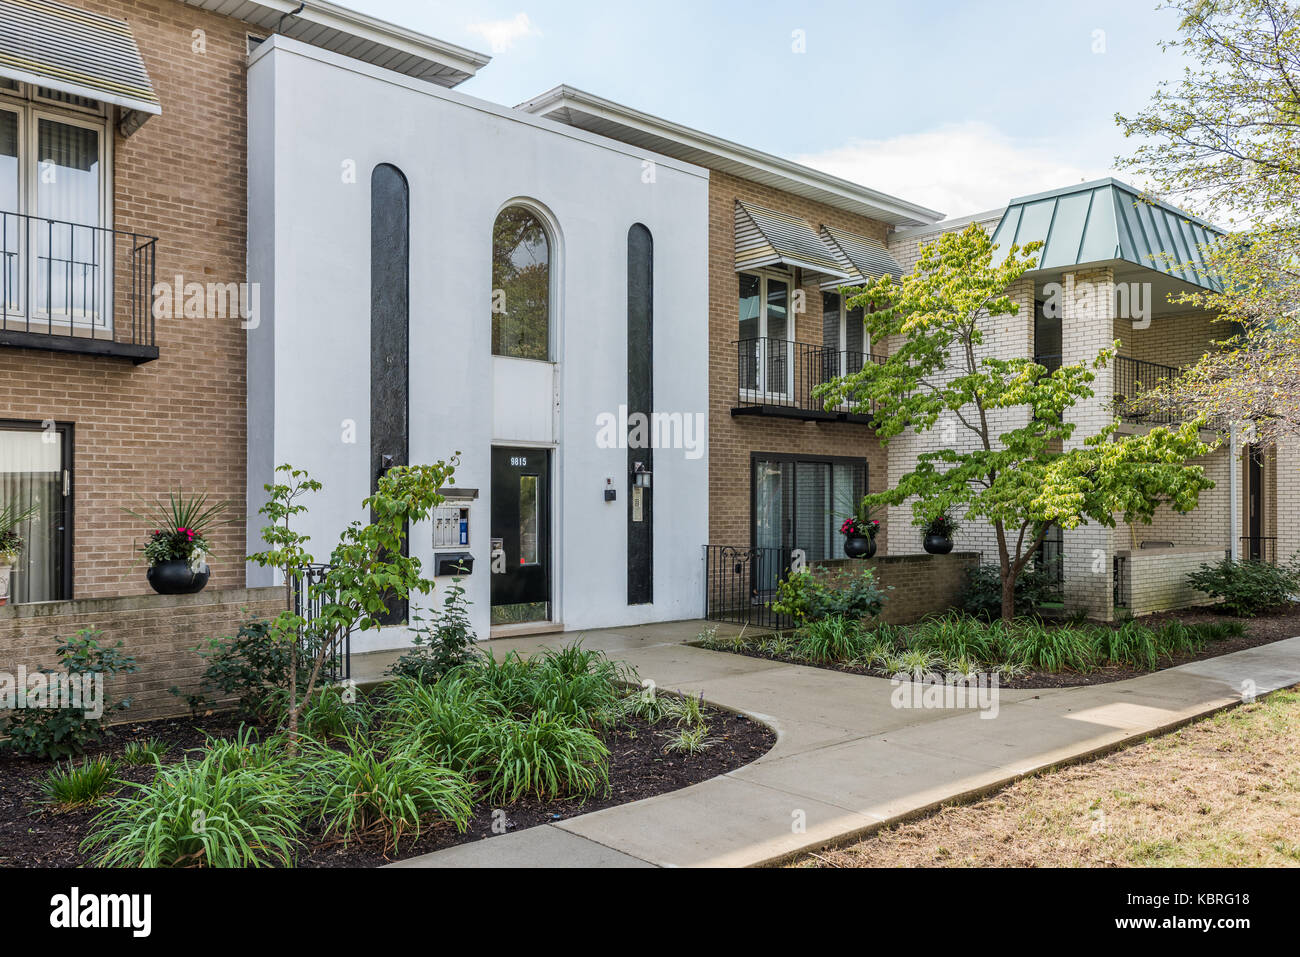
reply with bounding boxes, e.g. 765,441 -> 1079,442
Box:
31,118 -> 102,326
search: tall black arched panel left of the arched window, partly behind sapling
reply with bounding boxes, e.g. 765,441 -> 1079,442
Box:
371,163 -> 411,624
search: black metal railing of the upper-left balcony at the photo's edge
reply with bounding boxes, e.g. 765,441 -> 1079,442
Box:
0,211 -> 157,363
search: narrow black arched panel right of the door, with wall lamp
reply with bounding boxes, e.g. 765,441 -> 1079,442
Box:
628,222 -> 654,605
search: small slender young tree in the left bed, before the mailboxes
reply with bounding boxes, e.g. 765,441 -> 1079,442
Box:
248,452 -> 459,742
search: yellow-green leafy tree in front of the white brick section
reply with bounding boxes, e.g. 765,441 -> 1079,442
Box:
818,225 -> 1213,620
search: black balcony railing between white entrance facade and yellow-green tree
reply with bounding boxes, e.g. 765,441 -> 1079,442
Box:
732,338 -> 885,421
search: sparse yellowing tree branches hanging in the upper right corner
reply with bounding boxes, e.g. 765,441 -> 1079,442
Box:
1115,0 -> 1300,443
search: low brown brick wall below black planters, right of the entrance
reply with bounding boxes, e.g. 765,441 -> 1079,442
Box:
816,551 -> 979,624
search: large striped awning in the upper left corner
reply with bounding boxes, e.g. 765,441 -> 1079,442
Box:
0,0 -> 163,113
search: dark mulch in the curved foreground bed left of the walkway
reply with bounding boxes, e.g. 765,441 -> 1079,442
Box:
0,709 -> 776,867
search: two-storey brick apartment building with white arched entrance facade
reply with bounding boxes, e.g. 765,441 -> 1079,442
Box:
0,0 -> 1300,645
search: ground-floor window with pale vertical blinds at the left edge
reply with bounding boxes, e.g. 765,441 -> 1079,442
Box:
0,420 -> 73,603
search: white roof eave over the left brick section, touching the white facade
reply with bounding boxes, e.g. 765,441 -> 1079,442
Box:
182,0 -> 491,87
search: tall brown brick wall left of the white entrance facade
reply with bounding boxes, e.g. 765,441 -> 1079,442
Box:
0,0 -> 247,598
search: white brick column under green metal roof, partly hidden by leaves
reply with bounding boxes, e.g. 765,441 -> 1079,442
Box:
1061,268 -> 1115,622
